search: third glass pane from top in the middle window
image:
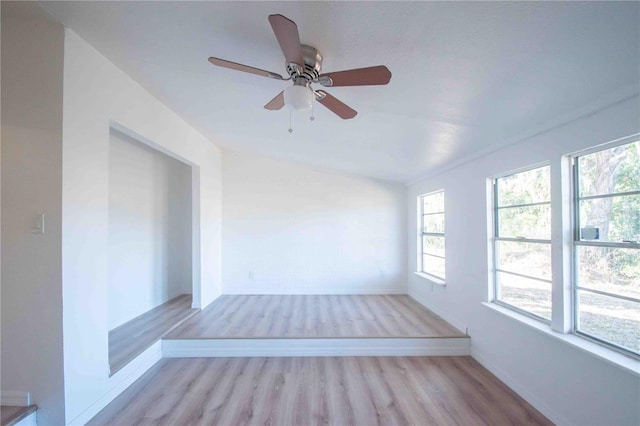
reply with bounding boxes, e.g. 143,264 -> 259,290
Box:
496,241 -> 551,280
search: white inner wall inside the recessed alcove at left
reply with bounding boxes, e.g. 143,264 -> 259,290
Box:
109,130 -> 191,329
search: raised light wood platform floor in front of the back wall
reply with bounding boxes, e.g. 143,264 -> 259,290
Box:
166,295 -> 464,339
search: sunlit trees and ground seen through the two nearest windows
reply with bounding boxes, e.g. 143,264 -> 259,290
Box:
497,142 -> 640,352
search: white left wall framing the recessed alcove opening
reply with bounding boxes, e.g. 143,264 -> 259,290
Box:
62,30 -> 221,422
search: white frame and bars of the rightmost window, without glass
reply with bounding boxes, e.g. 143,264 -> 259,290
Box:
570,142 -> 640,359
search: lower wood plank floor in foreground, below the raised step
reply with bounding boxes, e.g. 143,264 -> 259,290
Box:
88,357 -> 551,426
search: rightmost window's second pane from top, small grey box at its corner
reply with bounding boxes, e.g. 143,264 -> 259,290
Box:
580,194 -> 640,242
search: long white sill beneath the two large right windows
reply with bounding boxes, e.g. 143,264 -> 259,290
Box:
482,302 -> 640,377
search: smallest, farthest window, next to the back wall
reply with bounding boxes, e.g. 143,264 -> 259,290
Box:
420,190 -> 445,281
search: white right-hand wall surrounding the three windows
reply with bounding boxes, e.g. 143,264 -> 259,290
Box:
407,96 -> 640,425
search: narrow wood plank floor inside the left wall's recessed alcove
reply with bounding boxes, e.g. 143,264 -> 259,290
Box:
109,294 -> 199,375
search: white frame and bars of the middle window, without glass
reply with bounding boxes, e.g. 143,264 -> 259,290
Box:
491,162 -> 553,325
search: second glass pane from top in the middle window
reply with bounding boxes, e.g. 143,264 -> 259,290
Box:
498,204 -> 551,240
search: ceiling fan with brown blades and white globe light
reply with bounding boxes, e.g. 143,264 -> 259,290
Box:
209,15 -> 391,120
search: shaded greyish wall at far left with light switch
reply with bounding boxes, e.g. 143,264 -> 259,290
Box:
0,2 -> 64,424
